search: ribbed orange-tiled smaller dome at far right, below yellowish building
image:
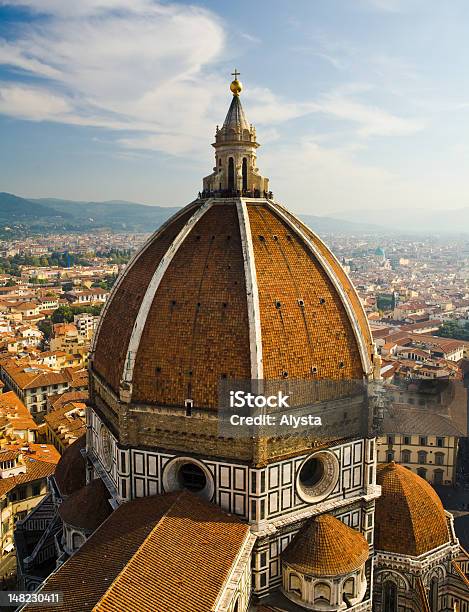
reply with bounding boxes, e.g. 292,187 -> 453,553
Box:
375,462 -> 450,557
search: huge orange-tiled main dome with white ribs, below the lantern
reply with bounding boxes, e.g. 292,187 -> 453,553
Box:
92,198 -> 373,408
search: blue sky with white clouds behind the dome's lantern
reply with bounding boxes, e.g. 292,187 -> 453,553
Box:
0,0 -> 469,215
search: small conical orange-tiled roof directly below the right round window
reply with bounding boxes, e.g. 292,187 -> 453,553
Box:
282,514 -> 369,577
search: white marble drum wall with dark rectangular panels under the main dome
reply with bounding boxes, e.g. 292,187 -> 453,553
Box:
88,409 -> 376,526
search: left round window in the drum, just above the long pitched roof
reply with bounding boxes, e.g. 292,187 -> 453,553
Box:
163,457 -> 215,500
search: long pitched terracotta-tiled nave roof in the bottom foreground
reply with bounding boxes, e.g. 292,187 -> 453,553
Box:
25,492 -> 250,612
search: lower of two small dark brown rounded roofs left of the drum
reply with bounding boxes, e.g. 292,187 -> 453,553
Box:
59,478 -> 112,531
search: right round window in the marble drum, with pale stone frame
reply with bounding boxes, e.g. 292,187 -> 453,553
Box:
296,451 -> 339,503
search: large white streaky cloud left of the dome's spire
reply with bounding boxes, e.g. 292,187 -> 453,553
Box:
0,0 -> 226,150
